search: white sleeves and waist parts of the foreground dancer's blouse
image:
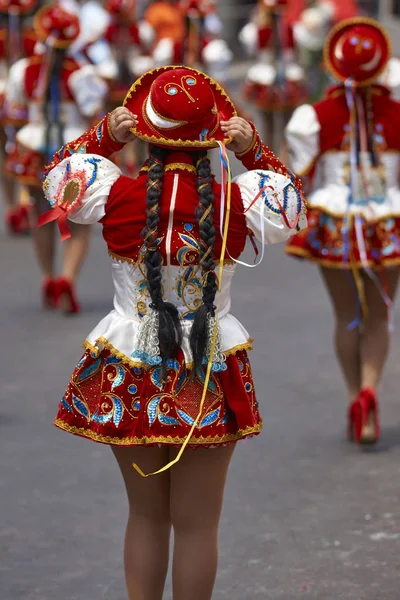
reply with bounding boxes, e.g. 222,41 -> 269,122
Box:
44,154 -> 307,366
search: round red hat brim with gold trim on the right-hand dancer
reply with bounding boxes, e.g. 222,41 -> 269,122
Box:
324,17 -> 392,87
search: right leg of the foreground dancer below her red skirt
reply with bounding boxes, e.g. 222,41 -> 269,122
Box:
171,445 -> 234,600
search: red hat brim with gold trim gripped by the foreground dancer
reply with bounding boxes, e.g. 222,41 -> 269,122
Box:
123,65 -> 237,150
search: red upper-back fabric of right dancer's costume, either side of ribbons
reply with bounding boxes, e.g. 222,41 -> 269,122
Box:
314,85 -> 400,154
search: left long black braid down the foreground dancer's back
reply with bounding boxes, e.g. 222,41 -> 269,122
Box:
142,146 -> 182,375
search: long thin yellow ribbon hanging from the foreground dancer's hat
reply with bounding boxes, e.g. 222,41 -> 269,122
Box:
133,144 -> 231,477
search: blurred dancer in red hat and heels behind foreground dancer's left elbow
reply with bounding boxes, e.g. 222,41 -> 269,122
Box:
6,5 -> 107,312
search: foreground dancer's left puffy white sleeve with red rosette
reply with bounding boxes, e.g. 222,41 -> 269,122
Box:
43,154 -> 121,225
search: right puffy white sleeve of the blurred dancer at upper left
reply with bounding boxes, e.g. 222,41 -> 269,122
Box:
68,65 -> 108,117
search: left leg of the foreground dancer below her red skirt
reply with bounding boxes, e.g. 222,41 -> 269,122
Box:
112,446 -> 171,600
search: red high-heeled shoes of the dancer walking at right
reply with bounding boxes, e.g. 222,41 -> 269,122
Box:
348,388 -> 380,444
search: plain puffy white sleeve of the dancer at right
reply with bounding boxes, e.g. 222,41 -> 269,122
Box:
285,104 -> 321,175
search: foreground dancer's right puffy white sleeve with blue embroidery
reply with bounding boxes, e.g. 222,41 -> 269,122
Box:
233,171 -> 307,244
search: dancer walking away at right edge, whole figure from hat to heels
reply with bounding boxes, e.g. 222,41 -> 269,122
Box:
287,17 -> 400,443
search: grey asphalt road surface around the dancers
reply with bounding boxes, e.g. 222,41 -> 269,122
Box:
0,149 -> 400,600
